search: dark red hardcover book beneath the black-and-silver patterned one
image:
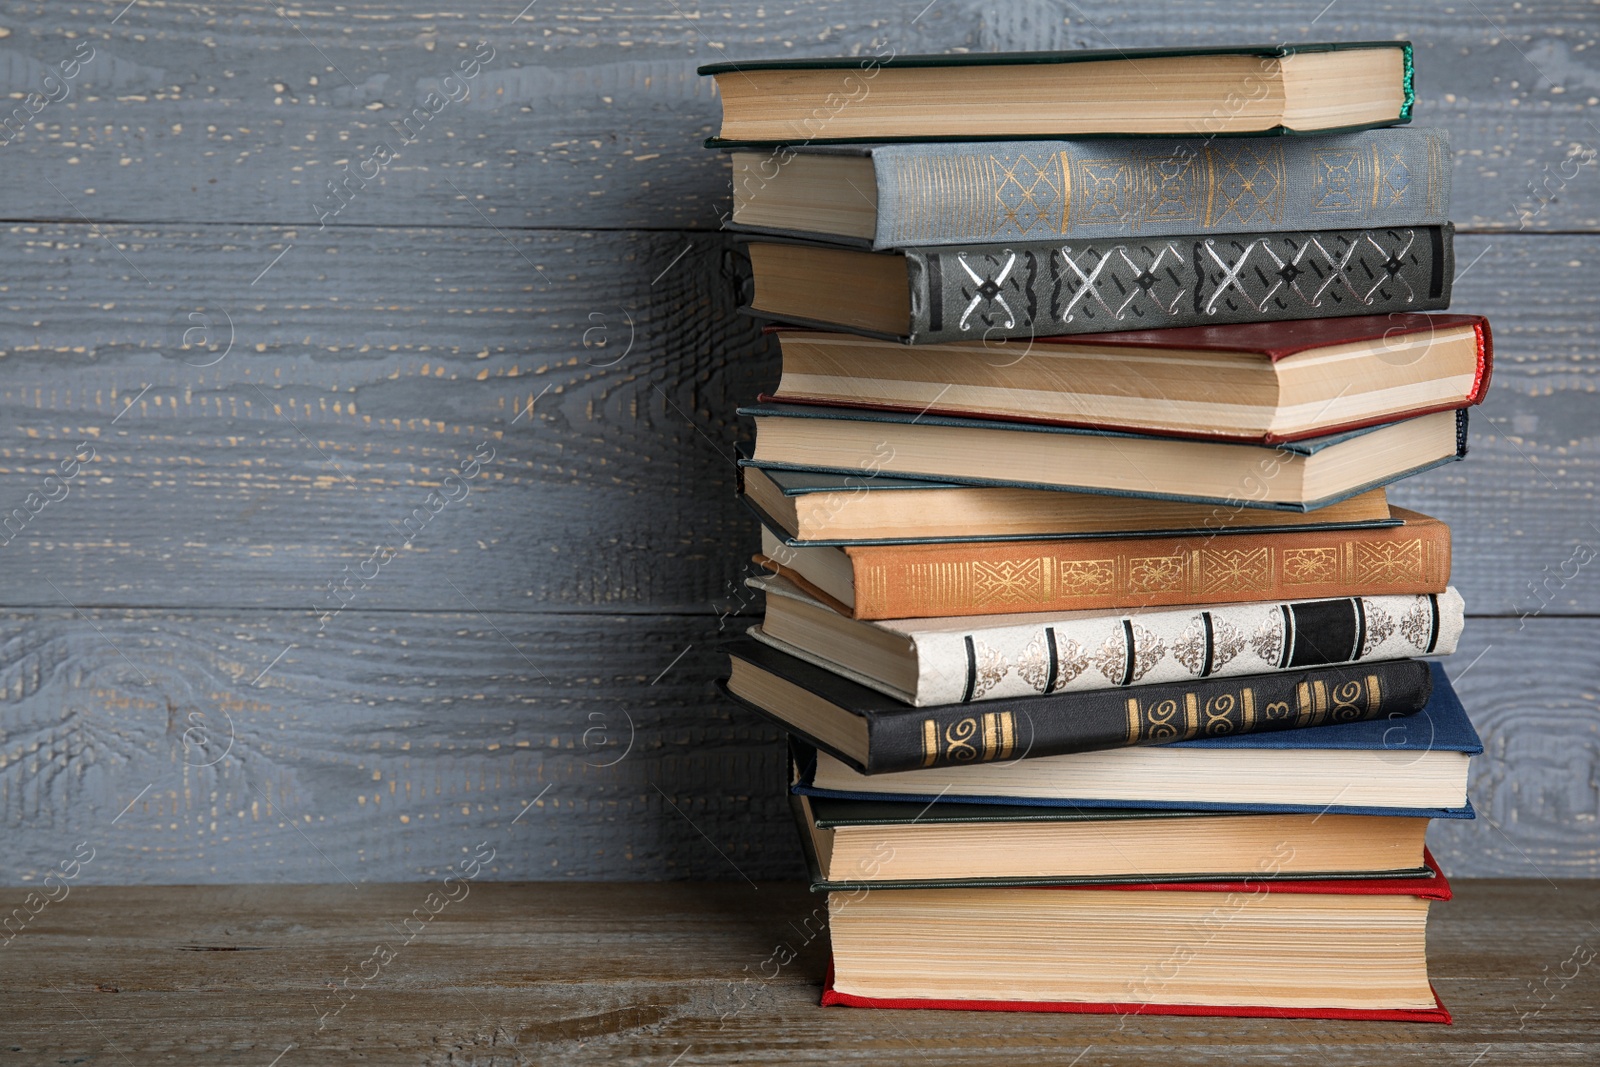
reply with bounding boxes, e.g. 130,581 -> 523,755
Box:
762,314 -> 1494,443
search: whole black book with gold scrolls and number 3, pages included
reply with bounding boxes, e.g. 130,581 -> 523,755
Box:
726,637 -> 1434,774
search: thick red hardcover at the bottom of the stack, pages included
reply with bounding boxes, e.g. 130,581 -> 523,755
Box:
822,856 -> 1451,1022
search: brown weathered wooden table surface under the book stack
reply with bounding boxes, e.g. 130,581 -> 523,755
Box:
0,880 -> 1600,1067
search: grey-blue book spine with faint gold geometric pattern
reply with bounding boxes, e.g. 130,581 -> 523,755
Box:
872,128 -> 1453,250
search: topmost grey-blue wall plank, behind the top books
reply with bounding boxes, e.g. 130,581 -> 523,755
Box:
0,0 -> 1600,230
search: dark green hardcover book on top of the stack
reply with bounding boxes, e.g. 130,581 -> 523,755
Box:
699,42 -> 1413,147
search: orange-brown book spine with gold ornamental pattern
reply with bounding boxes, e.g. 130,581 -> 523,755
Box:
845,520 -> 1450,619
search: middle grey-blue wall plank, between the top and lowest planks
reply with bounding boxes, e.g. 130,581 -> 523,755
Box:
0,224 -> 1600,614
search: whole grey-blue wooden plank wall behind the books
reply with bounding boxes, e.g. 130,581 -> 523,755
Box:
0,0 -> 1600,883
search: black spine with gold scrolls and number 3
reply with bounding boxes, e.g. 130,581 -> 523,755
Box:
867,659 -> 1432,774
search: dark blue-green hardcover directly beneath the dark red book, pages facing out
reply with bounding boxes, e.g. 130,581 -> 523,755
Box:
739,403 -> 1467,512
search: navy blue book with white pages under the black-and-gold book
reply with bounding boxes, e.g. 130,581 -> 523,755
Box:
794,664 -> 1483,819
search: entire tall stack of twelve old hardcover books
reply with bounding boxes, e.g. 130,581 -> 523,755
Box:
702,42 -> 1491,1022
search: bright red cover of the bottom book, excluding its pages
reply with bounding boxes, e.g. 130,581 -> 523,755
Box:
822,853 -> 1451,1025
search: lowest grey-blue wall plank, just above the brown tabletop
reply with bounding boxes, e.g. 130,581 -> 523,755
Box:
0,607 -> 1600,883
